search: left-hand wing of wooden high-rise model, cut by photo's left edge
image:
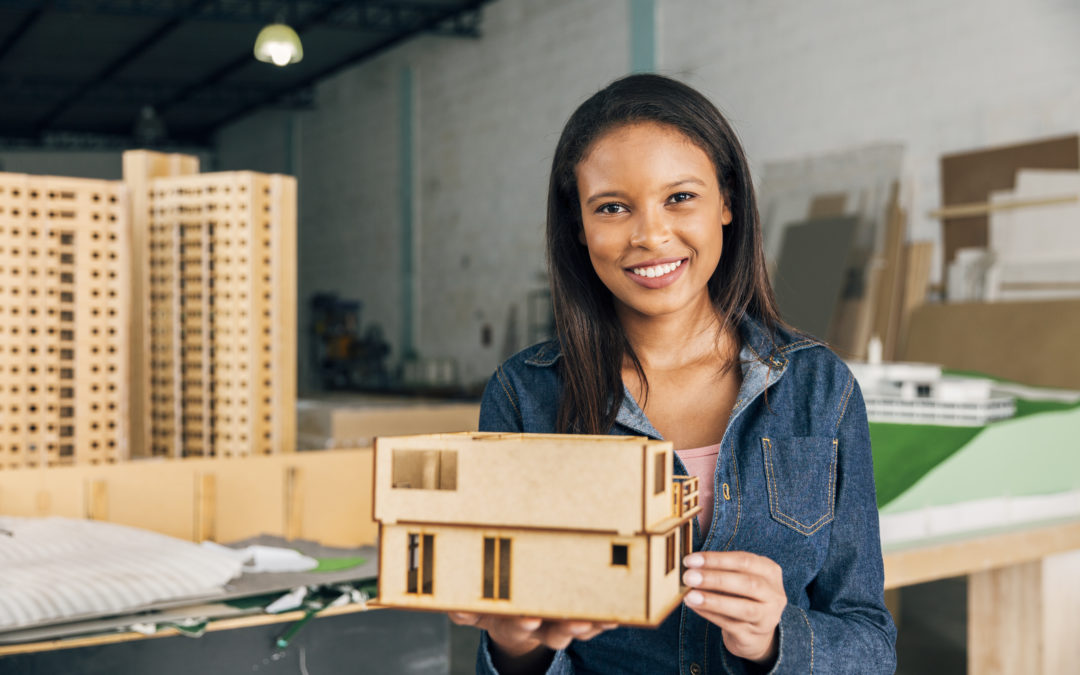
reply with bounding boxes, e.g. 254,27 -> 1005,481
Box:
0,173 -> 130,468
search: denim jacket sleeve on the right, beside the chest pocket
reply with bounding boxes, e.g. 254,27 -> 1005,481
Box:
747,376 -> 896,675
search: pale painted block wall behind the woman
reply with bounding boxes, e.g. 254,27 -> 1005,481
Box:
212,0 -> 1080,391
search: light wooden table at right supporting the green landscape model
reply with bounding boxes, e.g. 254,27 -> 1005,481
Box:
885,518 -> 1080,675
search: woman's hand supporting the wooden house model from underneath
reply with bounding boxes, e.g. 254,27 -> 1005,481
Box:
450,612 -> 617,672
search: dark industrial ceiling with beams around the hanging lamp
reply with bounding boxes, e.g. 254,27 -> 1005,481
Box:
0,0 -> 490,147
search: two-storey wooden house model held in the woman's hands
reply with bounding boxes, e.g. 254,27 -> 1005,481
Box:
374,432 -> 701,625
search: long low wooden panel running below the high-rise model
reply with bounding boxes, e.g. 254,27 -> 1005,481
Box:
0,448 -> 376,548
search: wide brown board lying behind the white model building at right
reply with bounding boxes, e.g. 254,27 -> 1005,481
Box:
900,300 -> 1080,389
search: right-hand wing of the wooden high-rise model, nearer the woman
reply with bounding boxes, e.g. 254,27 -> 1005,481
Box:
124,151 -> 296,457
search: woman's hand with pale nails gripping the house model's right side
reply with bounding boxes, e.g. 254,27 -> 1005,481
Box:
683,551 -> 787,664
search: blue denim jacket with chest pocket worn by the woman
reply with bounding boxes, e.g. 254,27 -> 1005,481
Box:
476,319 -> 896,675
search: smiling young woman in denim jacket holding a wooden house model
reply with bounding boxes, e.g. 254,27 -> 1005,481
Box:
451,75 -> 895,675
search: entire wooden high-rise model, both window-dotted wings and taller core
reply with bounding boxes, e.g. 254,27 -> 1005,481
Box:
0,150 -> 296,468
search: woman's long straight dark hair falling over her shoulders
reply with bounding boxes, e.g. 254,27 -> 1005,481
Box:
548,75 -> 781,434
